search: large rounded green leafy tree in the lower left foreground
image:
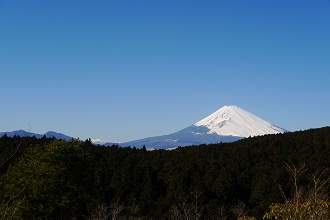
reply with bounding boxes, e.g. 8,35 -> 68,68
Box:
1,140 -> 92,219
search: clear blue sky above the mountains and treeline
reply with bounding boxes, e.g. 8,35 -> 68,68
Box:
0,0 -> 330,142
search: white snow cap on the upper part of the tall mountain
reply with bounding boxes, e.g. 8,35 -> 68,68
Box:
194,106 -> 286,137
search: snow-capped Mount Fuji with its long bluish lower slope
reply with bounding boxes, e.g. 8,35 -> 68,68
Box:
115,106 -> 287,149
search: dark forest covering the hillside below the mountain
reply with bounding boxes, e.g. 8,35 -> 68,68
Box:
0,127 -> 330,220
